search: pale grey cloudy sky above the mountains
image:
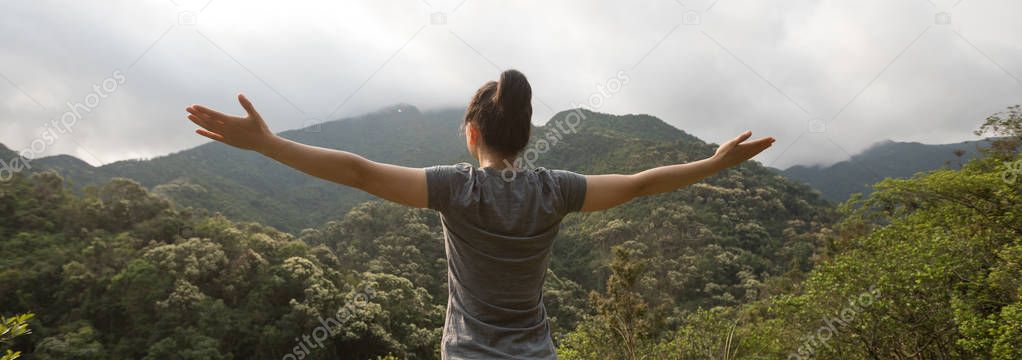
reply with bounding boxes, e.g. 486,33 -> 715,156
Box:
0,0 -> 1022,168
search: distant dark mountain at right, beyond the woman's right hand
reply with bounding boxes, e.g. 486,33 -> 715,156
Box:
782,140 -> 987,203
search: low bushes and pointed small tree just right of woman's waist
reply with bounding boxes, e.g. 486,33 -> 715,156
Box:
558,247 -> 797,360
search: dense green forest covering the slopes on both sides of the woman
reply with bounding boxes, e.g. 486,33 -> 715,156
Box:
0,106 -> 1022,359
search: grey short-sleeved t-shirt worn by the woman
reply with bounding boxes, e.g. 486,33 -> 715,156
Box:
425,164 -> 586,359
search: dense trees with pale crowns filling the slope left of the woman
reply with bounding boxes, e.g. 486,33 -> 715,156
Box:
0,173 -> 444,359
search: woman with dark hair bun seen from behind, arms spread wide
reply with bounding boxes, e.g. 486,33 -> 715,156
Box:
187,70 -> 774,359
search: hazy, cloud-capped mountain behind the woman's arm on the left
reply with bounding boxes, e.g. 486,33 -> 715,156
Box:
4,104 -> 467,232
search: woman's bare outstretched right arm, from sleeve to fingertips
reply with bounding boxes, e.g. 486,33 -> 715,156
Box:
582,131 -> 774,212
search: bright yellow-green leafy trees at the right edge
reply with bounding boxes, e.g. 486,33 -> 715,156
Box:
772,151 -> 1022,358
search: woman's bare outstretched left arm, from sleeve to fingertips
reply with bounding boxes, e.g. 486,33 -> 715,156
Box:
187,95 -> 427,208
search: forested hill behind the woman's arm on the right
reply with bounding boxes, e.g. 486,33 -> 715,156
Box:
533,110 -> 836,317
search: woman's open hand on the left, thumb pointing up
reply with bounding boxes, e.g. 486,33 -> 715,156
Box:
186,94 -> 274,150
